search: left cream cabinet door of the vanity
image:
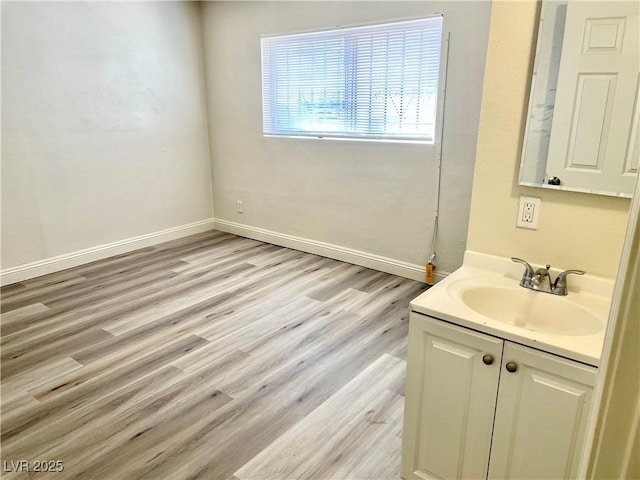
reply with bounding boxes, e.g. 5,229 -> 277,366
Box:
402,313 -> 503,480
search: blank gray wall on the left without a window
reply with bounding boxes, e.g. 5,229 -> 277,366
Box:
2,2 -> 213,268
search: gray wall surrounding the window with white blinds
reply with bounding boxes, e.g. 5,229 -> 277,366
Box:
204,1 -> 491,271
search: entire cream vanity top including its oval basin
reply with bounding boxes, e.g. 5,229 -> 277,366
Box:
411,250 -> 614,367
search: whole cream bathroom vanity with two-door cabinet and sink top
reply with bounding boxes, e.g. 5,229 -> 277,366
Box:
402,252 -> 613,480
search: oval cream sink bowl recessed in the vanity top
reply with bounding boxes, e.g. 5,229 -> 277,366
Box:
460,286 -> 604,335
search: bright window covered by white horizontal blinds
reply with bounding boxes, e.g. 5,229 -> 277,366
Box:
262,15 -> 442,142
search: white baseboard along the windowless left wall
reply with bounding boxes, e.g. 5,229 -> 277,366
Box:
0,218 -> 214,285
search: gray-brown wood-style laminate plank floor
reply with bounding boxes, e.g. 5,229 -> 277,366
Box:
0,232 -> 425,480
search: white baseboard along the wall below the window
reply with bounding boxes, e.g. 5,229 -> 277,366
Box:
214,218 -> 449,282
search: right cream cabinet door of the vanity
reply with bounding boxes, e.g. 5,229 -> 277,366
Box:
489,342 -> 596,479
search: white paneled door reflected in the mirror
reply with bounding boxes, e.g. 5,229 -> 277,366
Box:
547,1 -> 640,193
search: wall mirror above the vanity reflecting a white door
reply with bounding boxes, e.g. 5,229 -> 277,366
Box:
520,0 -> 640,197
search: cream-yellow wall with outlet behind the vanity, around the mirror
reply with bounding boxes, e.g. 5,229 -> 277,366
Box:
467,0 -> 630,277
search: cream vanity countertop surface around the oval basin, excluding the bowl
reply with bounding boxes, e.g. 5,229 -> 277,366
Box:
410,251 -> 614,367
